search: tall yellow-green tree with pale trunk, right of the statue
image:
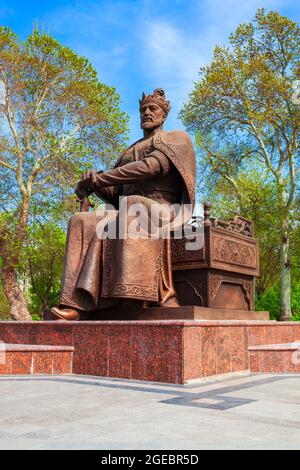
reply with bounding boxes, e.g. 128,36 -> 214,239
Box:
181,9 -> 300,320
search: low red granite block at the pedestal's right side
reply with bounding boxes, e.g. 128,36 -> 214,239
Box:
248,341 -> 300,373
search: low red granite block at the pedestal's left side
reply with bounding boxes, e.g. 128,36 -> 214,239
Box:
0,342 -> 74,375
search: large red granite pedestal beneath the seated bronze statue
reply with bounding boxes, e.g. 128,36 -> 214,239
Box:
0,320 -> 300,384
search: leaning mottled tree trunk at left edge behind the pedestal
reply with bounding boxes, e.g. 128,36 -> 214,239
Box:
1,266 -> 32,321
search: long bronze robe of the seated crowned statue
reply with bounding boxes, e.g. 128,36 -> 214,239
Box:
60,131 -> 196,311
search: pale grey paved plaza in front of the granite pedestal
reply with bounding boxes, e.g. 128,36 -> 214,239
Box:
0,373 -> 300,449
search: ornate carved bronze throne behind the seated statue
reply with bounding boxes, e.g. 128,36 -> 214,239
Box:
172,203 -> 259,311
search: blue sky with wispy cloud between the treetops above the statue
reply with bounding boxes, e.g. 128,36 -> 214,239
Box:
0,0 -> 300,140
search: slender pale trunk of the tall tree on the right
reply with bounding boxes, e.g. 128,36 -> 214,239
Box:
280,235 -> 292,321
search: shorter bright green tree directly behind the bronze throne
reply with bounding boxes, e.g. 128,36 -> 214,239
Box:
201,165 -> 280,294
